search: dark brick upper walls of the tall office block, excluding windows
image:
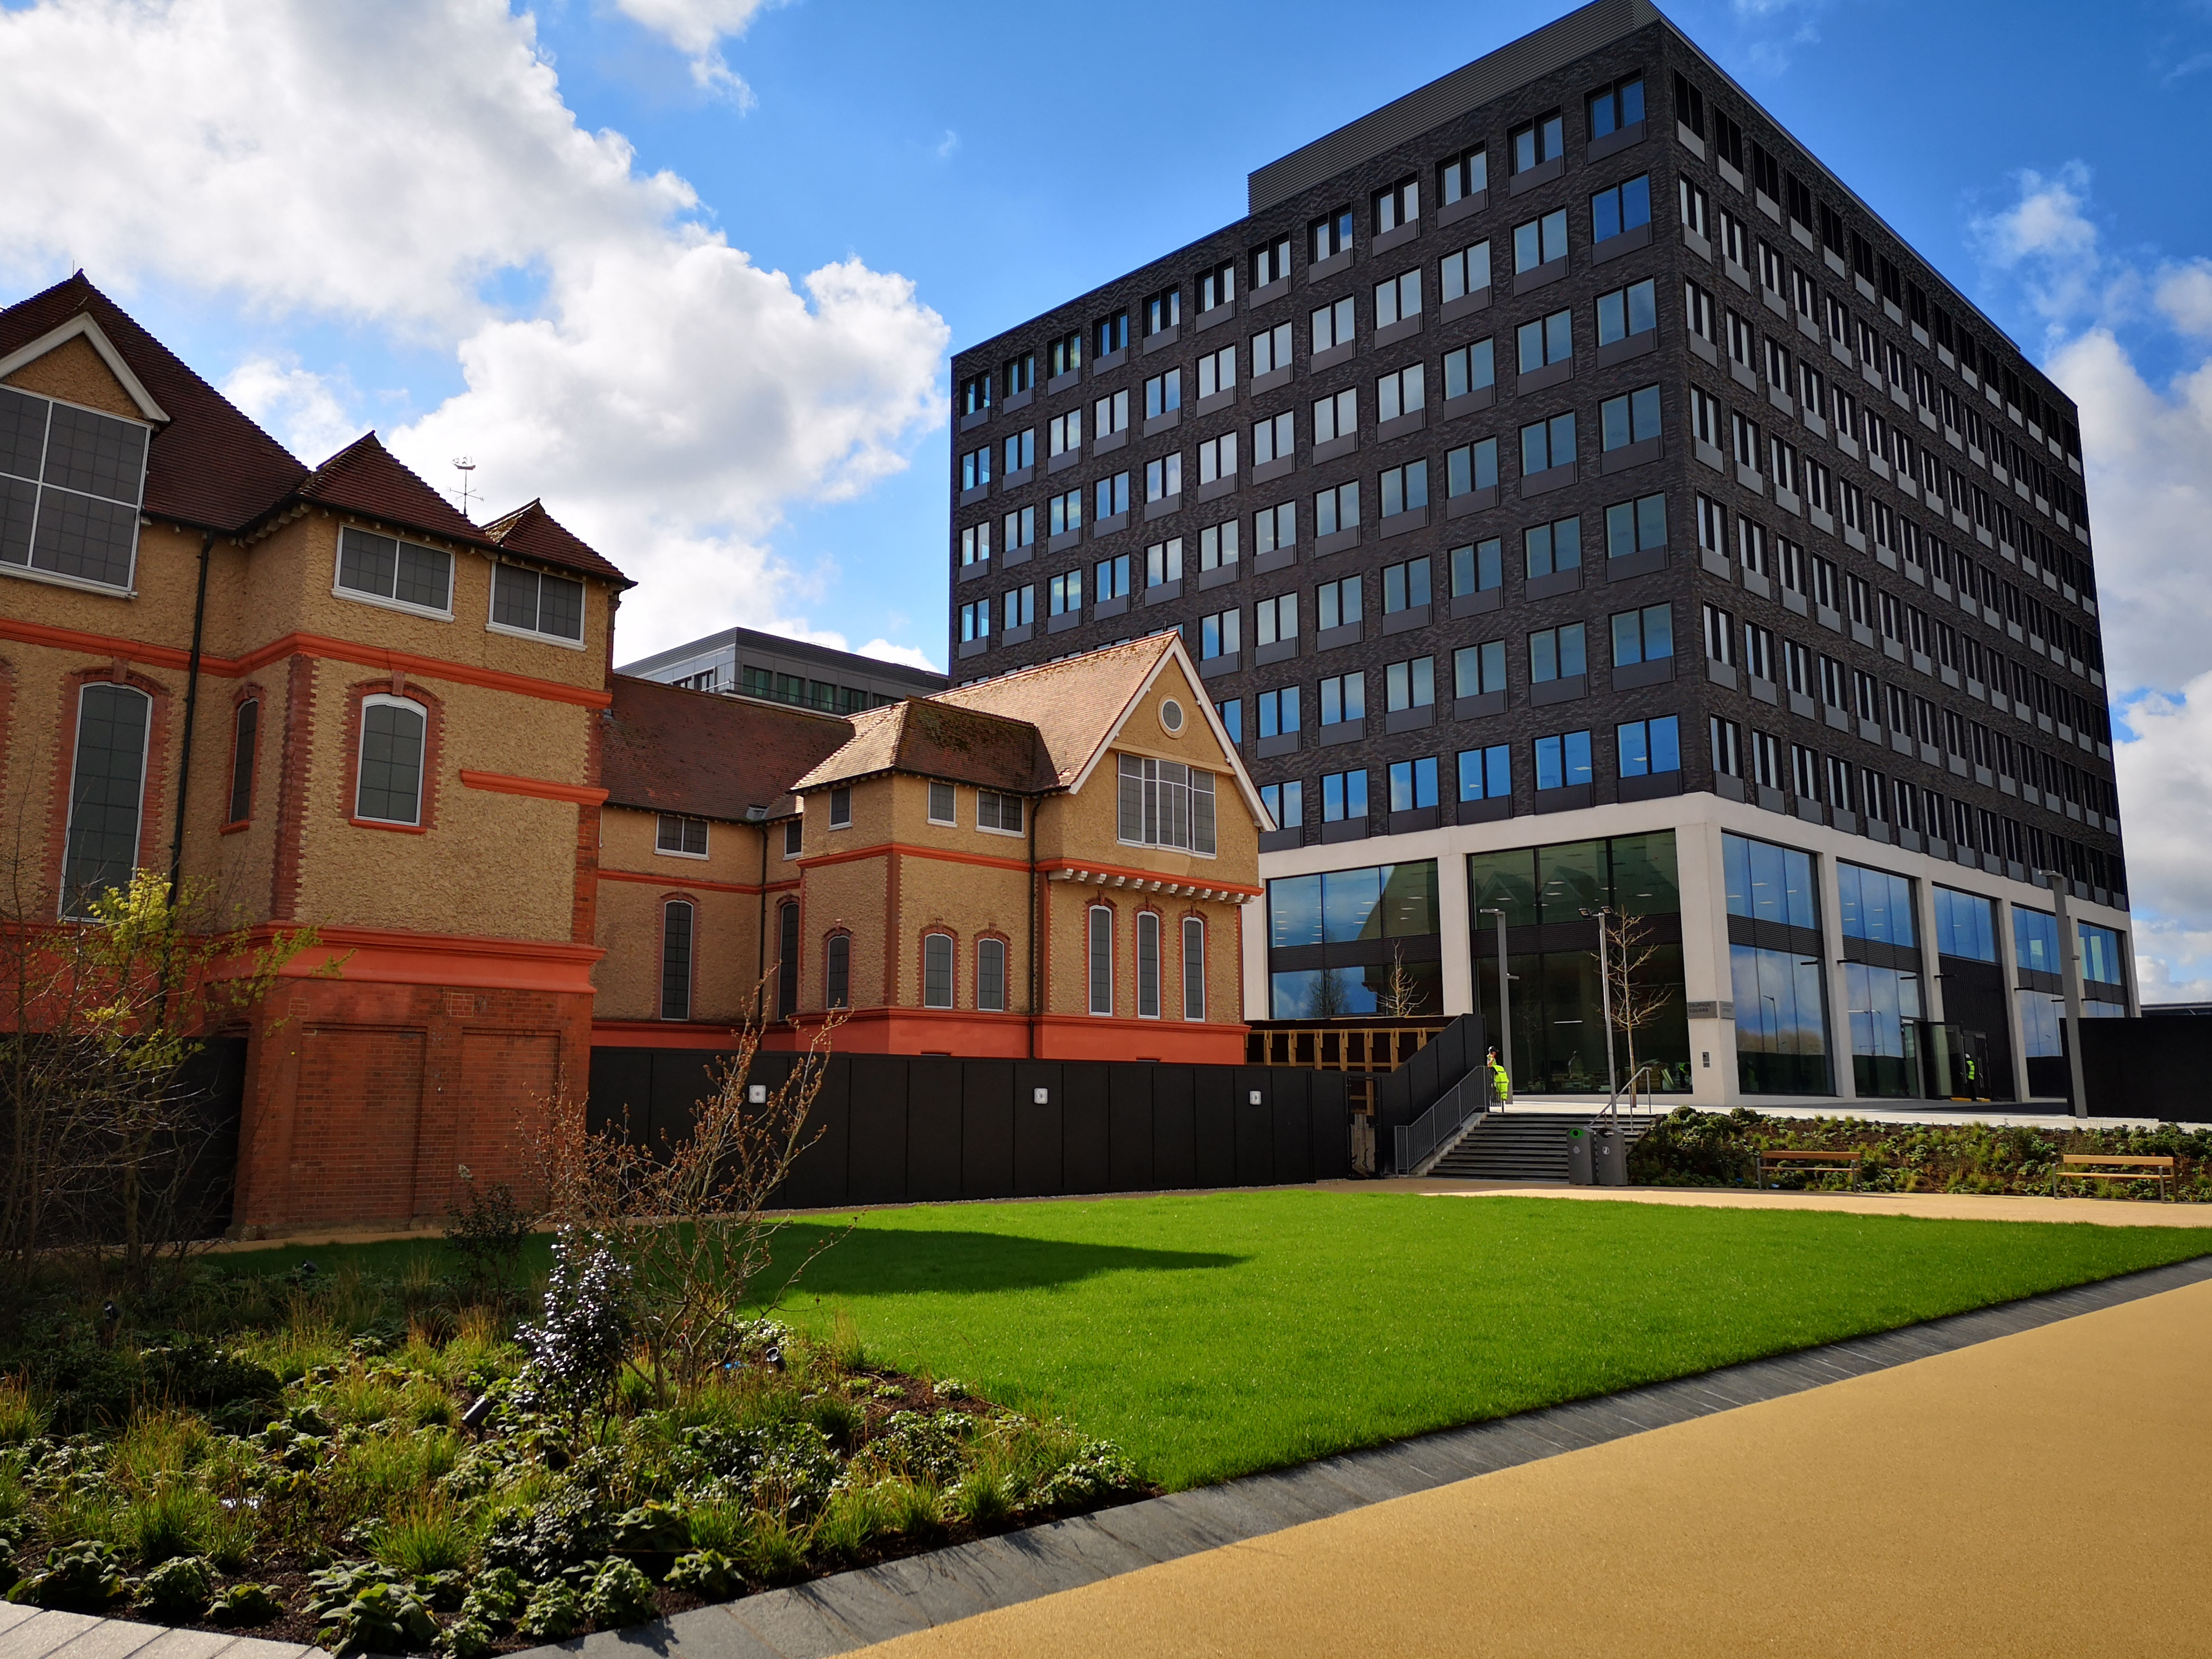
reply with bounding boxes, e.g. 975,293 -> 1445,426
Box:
949,9 -> 2126,903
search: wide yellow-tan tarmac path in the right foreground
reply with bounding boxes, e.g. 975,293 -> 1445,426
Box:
863,1283 -> 2212,1659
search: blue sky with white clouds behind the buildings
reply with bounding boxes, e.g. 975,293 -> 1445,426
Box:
0,0 -> 2212,996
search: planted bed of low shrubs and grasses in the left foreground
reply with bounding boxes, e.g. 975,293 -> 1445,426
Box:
0,1272 -> 1154,1659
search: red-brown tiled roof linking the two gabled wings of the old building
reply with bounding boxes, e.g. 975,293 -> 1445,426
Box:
599,675 -> 852,823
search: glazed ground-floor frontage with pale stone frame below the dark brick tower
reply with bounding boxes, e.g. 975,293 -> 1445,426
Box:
1245,796 -> 2132,1106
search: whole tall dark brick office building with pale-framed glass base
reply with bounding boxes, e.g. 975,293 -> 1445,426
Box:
949,0 -> 2135,1119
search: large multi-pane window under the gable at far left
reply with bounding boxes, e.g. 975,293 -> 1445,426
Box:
0,387 -> 146,590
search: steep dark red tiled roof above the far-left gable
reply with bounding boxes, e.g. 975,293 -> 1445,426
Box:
0,272 -> 308,533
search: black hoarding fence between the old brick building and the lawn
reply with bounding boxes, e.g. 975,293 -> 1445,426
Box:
588,1049 -> 1351,1210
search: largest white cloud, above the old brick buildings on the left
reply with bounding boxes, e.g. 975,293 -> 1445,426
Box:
0,0 -> 949,657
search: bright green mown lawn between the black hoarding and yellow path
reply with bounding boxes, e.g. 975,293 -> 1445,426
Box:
230,1192 -> 2212,1486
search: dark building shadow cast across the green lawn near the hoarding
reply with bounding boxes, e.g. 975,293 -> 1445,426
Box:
759,1221 -> 1250,1301
